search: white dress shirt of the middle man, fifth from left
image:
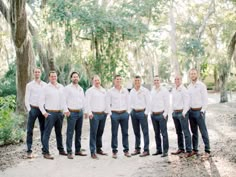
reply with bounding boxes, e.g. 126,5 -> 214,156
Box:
108,87 -> 130,114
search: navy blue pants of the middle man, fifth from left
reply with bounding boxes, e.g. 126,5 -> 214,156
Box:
111,112 -> 129,153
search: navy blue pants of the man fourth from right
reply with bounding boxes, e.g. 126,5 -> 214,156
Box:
131,110 -> 149,152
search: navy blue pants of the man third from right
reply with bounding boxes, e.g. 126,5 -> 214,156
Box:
151,114 -> 169,153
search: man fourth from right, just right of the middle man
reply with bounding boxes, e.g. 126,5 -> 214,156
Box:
130,76 -> 150,157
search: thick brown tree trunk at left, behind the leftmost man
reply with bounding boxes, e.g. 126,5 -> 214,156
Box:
10,0 -> 35,113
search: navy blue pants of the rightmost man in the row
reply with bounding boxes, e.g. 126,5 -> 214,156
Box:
189,109 -> 210,153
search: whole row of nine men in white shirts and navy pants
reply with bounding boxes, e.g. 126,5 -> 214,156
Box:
25,68 -> 210,159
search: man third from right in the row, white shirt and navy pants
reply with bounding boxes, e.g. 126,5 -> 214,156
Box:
151,76 -> 170,157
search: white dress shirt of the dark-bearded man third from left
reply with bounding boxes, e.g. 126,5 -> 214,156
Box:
65,83 -> 85,110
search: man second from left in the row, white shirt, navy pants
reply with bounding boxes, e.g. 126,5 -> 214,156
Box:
39,71 -> 69,159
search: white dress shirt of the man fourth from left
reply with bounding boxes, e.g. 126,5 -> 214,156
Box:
85,86 -> 109,115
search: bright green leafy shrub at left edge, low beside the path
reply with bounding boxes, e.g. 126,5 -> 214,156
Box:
0,96 -> 24,145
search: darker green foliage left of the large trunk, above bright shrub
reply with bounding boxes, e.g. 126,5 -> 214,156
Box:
0,63 -> 16,97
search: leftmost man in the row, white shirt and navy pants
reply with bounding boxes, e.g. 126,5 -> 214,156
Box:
25,68 -> 47,158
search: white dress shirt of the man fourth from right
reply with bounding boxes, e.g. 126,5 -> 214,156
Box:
130,86 -> 150,115
